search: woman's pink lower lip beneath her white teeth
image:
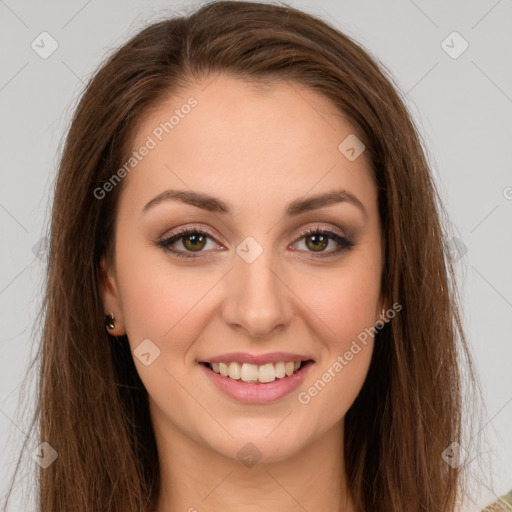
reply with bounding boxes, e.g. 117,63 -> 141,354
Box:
199,361 -> 313,404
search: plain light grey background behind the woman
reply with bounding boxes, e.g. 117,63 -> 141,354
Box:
0,0 -> 512,510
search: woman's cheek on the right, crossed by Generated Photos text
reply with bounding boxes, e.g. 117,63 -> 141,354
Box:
290,260 -> 380,416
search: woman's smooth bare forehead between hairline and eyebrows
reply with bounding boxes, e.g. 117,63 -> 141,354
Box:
123,76 -> 375,218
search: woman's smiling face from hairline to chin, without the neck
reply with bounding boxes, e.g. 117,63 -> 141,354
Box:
102,76 -> 386,461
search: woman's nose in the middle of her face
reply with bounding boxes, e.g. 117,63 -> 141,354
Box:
222,250 -> 293,339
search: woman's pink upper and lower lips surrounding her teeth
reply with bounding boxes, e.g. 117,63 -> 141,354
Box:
199,360 -> 314,404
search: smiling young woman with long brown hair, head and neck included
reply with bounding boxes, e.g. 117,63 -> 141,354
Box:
4,2 -> 486,512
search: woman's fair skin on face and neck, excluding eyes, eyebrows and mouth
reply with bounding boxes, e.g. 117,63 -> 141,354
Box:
102,76 -> 389,512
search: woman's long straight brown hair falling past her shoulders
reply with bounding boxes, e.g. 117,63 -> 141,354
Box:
2,1 -> 473,512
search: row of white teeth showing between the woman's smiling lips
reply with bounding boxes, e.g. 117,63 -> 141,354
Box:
200,359 -> 314,384
